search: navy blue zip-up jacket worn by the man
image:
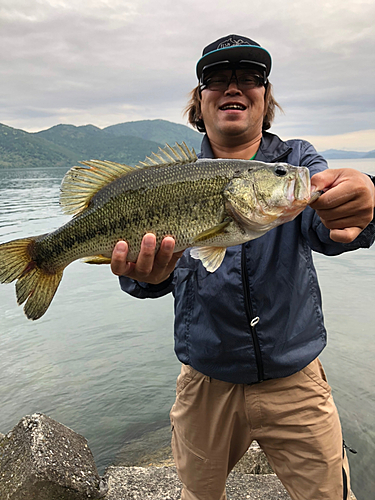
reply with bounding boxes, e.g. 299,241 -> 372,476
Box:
120,132 -> 375,384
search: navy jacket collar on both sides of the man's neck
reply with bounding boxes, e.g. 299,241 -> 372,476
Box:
198,132 -> 292,163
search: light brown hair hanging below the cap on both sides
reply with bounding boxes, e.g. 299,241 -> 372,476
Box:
184,82 -> 283,132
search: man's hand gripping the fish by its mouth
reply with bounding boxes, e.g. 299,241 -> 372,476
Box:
311,168 -> 375,243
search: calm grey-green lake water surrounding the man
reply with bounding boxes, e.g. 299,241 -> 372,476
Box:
0,159 -> 375,500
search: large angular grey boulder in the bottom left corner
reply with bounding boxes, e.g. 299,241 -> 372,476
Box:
0,413 -> 105,500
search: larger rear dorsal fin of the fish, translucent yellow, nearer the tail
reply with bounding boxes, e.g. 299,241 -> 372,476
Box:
60,160 -> 139,215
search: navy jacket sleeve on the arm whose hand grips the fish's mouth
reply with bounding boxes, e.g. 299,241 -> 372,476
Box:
300,141 -> 375,255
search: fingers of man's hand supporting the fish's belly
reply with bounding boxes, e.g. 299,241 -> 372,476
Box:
111,233 -> 183,285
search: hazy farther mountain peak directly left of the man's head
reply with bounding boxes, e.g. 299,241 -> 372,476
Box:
103,120 -> 202,151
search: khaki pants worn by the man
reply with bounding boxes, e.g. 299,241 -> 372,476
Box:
170,359 -> 350,500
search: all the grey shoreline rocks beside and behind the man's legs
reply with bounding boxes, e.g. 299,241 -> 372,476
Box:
0,413 -> 355,500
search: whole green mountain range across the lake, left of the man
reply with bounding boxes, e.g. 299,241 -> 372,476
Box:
0,120 -> 201,169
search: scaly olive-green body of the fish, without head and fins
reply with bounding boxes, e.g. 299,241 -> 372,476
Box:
34,161 -> 235,271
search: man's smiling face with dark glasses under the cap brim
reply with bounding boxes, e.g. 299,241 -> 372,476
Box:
201,69 -> 265,146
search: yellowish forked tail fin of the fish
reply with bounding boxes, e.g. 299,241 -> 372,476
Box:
0,238 -> 63,320
